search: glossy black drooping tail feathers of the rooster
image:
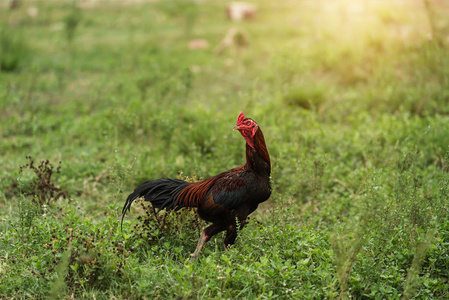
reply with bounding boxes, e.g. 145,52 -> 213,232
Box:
120,178 -> 189,228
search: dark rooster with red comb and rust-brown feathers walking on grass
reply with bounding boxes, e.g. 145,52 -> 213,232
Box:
121,112 -> 271,260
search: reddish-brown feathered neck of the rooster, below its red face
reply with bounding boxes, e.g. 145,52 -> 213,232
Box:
245,127 -> 271,178
